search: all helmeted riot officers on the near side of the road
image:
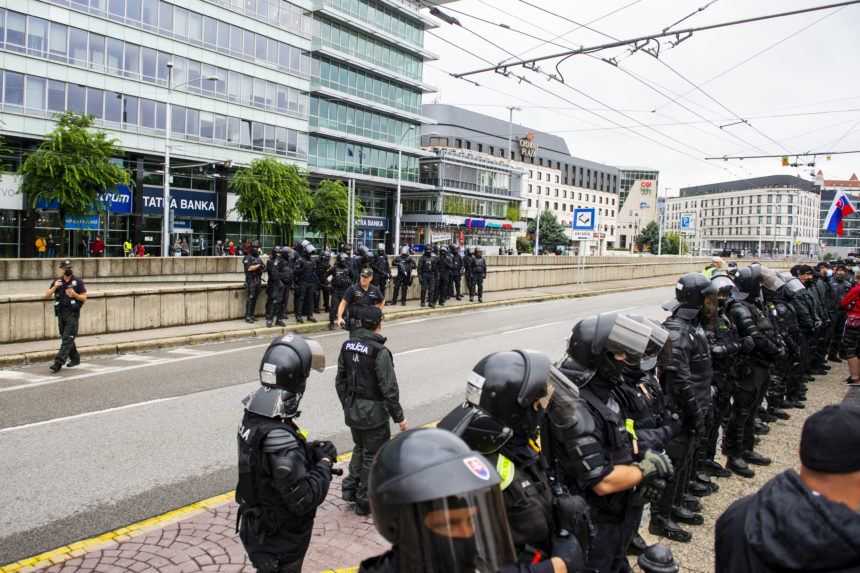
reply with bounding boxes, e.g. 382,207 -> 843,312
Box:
230,264 -> 850,573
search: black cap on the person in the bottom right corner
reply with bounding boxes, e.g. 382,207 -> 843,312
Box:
800,405 -> 860,474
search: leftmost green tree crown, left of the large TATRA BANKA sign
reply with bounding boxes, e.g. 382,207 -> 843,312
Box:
20,112 -> 129,215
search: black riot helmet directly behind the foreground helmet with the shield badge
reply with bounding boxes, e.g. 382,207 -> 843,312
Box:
466,350 -> 552,436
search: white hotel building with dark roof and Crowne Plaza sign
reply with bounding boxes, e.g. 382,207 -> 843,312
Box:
422,104 -> 619,252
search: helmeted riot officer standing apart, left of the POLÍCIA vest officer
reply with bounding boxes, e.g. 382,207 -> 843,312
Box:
236,333 -> 337,573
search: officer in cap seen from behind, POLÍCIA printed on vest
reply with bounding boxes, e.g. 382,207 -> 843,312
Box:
335,306 -> 408,515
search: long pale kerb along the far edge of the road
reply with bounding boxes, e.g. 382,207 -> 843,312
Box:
0,278 -> 676,366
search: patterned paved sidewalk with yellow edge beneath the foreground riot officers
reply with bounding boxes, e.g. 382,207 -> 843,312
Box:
0,364 -> 857,573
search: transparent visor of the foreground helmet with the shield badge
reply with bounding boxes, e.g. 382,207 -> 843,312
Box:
399,488 -> 516,573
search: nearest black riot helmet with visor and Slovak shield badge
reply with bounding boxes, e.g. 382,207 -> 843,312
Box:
368,428 -> 516,573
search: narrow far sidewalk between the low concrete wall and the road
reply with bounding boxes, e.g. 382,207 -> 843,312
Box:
0,276 -> 676,366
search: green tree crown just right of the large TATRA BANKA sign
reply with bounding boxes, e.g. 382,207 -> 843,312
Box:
230,157 -> 311,242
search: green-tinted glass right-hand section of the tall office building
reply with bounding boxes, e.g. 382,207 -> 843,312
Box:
308,0 -> 439,248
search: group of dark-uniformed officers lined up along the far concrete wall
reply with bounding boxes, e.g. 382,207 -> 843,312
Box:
242,240 -> 487,330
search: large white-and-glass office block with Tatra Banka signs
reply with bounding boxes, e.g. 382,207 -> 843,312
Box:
0,0 -> 444,256
